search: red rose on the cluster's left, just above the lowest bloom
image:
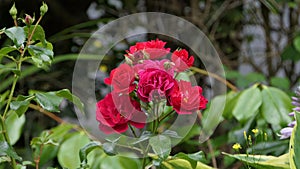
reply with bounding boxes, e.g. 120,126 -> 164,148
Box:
104,64 -> 136,94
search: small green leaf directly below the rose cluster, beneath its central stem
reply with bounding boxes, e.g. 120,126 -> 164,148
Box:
149,135 -> 171,159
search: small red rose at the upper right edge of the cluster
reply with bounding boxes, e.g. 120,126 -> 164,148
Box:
171,49 -> 194,72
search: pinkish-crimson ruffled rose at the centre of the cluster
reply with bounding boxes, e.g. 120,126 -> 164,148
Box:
137,68 -> 176,102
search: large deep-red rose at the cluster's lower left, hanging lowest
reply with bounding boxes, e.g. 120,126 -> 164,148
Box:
96,93 -> 146,134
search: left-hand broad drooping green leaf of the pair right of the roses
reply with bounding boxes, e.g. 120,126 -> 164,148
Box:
232,85 -> 262,123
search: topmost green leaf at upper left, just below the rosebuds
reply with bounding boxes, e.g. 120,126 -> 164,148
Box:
4,27 -> 26,48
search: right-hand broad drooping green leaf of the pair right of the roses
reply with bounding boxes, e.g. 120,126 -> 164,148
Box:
261,86 -> 292,131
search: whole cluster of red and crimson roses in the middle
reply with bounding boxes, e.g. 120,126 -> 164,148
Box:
96,39 -> 207,134
